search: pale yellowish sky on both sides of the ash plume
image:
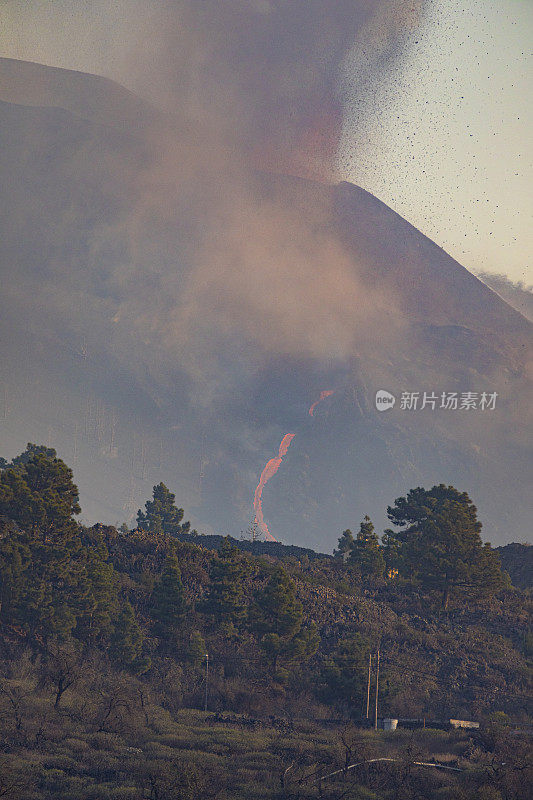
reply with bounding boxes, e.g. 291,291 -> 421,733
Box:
0,0 -> 533,283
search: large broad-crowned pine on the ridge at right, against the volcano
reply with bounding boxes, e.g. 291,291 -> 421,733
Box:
387,484 -> 504,608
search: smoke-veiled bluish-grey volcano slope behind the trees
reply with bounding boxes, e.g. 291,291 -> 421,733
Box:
0,54 -> 531,548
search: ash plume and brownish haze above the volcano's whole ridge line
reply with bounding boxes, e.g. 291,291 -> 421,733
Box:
3,0 -> 424,178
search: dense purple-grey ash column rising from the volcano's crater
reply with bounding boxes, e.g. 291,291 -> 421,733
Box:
137,0 -> 424,180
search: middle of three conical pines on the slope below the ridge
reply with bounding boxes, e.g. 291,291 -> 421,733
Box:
204,536 -> 246,627
